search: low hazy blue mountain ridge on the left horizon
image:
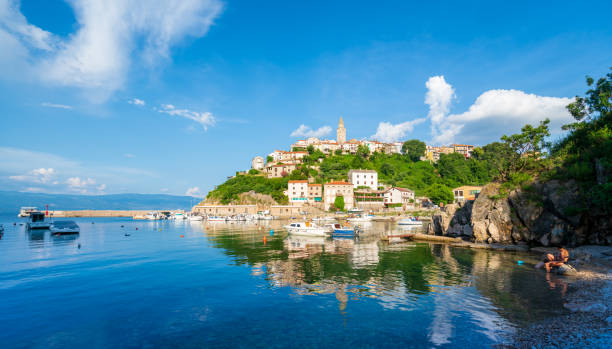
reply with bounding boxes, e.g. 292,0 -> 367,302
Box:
0,190 -> 201,214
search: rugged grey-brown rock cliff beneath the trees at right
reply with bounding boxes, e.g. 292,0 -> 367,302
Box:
429,180 -> 612,246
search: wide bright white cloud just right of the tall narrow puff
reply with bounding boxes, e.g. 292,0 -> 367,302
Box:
432,89 -> 572,144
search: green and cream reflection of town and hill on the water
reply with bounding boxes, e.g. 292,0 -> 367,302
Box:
206,223 -> 562,344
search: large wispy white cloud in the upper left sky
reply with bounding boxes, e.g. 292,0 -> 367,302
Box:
0,0 -> 223,98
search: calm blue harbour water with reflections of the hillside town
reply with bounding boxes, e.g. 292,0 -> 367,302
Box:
0,216 -> 563,348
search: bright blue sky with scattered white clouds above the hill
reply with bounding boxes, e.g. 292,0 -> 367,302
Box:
0,0 -> 612,196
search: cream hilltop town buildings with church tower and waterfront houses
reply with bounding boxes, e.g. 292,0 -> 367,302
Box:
198,117 -> 481,215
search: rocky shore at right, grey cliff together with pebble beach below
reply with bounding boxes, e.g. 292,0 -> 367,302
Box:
415,180 -> 612,348
